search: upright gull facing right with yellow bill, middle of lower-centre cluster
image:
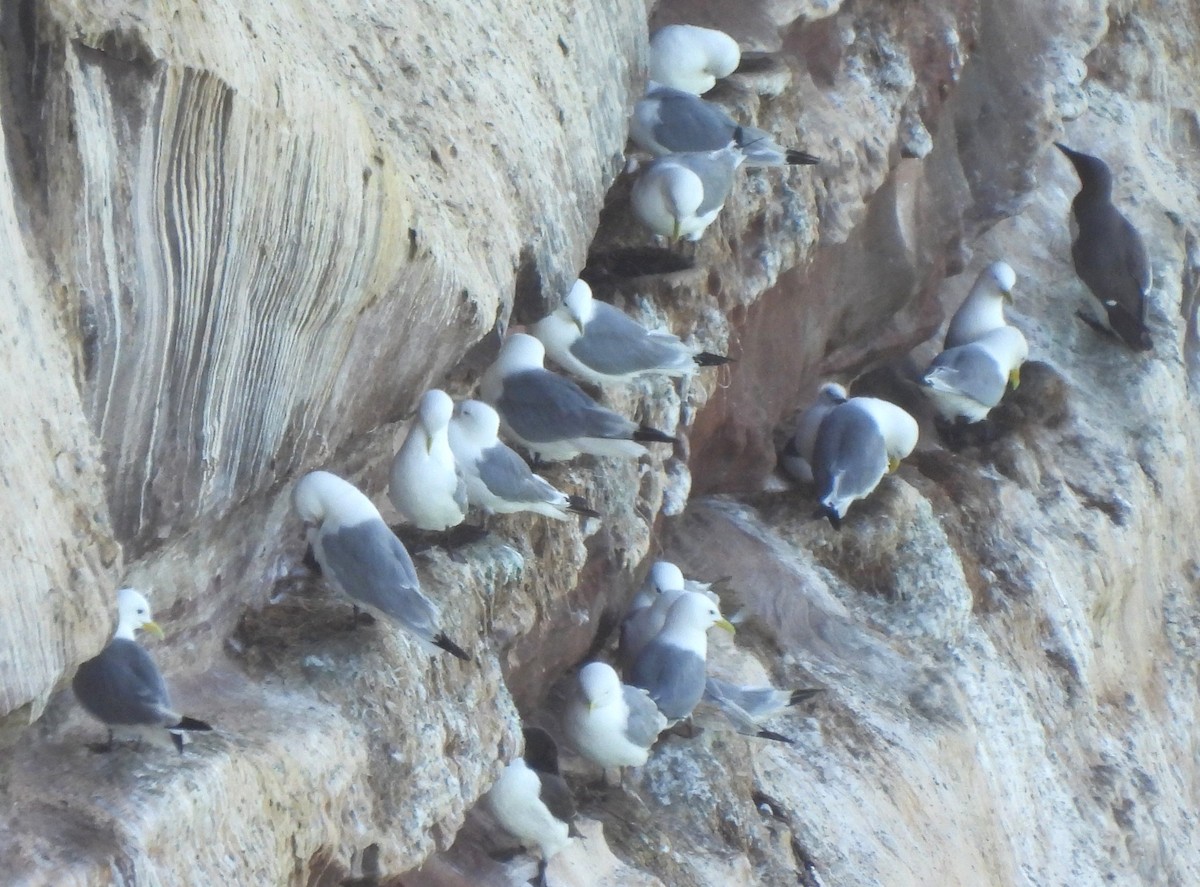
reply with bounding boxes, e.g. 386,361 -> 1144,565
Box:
629,592 -> 733,721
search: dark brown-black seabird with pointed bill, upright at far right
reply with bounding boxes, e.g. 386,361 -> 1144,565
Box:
1055,142 -> 1153,350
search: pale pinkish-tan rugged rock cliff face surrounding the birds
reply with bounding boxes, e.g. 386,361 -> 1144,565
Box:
0,0 -> 1200,886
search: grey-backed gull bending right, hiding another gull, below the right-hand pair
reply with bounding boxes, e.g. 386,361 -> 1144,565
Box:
812,397 -> 917,528
